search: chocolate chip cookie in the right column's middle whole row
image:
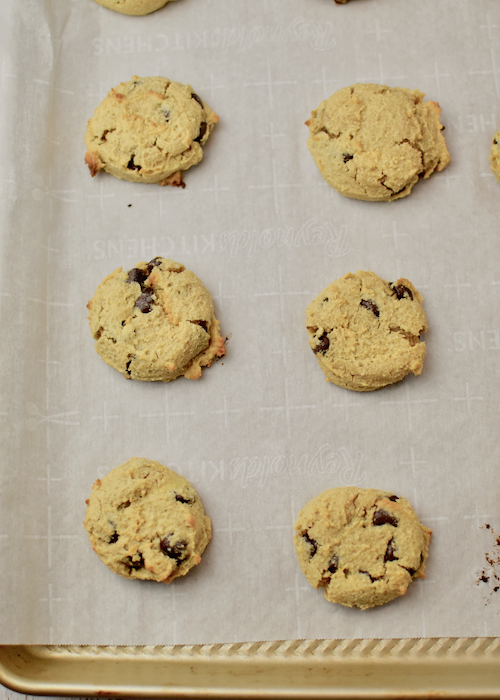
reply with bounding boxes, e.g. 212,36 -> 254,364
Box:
306,270 -> 427,391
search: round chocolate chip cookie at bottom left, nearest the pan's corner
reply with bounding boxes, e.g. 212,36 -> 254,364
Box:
84,457 -> 212,583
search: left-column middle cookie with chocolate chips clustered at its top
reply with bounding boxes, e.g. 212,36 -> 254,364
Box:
87,257 -> 226,382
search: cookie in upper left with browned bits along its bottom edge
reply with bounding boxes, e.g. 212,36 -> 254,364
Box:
85,76 -> 219,187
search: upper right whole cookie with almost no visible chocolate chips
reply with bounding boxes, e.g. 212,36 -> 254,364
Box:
306,84 -> 450,202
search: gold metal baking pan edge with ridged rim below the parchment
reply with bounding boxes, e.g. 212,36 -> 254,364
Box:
0,637 -> 500,699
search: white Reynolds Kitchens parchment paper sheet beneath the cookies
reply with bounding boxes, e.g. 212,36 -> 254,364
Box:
0,0 -> 500,644
